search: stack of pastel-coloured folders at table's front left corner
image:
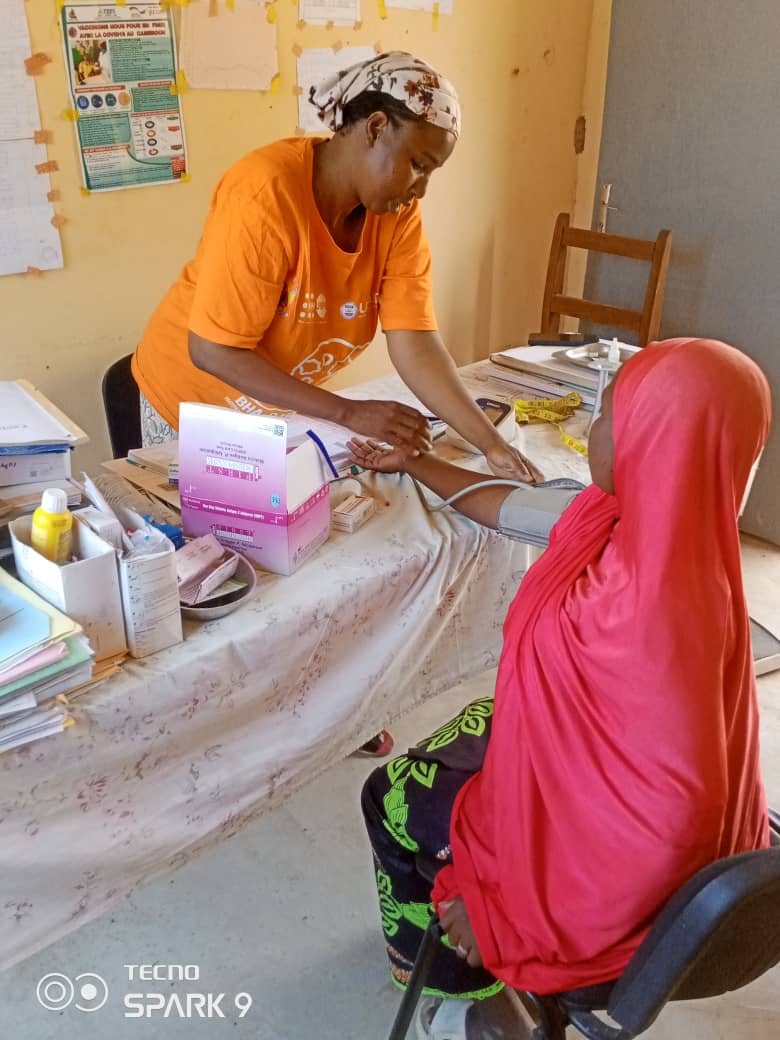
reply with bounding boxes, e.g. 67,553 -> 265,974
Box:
0,570 -> 94,752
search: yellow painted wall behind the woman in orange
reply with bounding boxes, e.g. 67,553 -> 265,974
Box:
0,0 -> 605,467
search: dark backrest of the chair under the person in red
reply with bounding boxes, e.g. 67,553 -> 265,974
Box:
607,848 -> 780,1036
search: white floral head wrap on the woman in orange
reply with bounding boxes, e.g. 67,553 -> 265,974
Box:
309,51 -> 461,137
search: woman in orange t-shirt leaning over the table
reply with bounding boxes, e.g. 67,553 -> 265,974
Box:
133,51 -> 539,480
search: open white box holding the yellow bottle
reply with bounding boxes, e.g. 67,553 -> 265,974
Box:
8,517 -> 127,660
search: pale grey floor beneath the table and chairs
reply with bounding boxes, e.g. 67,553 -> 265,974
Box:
0,540 -> 780,1040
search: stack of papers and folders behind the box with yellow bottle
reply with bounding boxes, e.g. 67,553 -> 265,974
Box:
0,380 -> 87,532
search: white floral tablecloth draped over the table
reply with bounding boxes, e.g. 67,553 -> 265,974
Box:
0,365 -> 587,968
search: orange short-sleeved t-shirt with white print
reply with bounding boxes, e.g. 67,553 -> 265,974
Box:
133,137 -> 437,427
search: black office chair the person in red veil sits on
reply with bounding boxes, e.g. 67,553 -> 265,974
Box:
389,812 -> 780,1040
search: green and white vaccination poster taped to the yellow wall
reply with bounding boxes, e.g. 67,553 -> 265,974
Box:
62,3 -> 187,191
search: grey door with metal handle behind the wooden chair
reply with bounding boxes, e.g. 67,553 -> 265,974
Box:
587,0 -> 780,544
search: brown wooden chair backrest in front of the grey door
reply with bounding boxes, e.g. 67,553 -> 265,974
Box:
542,213 -> 672,346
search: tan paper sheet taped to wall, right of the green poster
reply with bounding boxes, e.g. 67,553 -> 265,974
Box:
179,0 -> 279,90
